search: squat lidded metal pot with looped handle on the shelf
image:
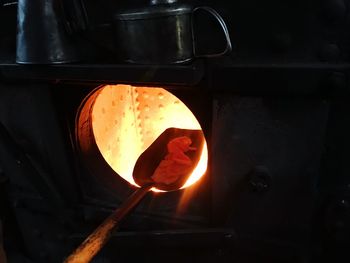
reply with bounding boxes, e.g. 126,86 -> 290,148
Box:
114,0 -> 232,64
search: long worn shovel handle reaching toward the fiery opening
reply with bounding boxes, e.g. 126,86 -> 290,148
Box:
64,185 -> 153,263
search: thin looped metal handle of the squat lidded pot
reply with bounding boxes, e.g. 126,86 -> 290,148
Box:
191,6 -> 232,58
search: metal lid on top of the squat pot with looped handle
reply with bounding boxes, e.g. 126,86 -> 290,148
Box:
114,4 -> 192,20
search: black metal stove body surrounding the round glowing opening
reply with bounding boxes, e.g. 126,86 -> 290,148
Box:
0,1 -> 350,263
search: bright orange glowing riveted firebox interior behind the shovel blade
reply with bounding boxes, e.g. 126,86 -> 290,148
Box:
92,84 -> 208,191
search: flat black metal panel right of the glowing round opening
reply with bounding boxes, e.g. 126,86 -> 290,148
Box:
212,95 -> 329,246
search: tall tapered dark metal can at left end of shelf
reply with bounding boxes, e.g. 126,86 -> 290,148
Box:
16,0 -> 77,64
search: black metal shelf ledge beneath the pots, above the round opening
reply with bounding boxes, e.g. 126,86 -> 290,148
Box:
0,62 -> 204,86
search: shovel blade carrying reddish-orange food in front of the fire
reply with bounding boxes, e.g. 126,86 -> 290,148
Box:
133,128 -> 205,191
